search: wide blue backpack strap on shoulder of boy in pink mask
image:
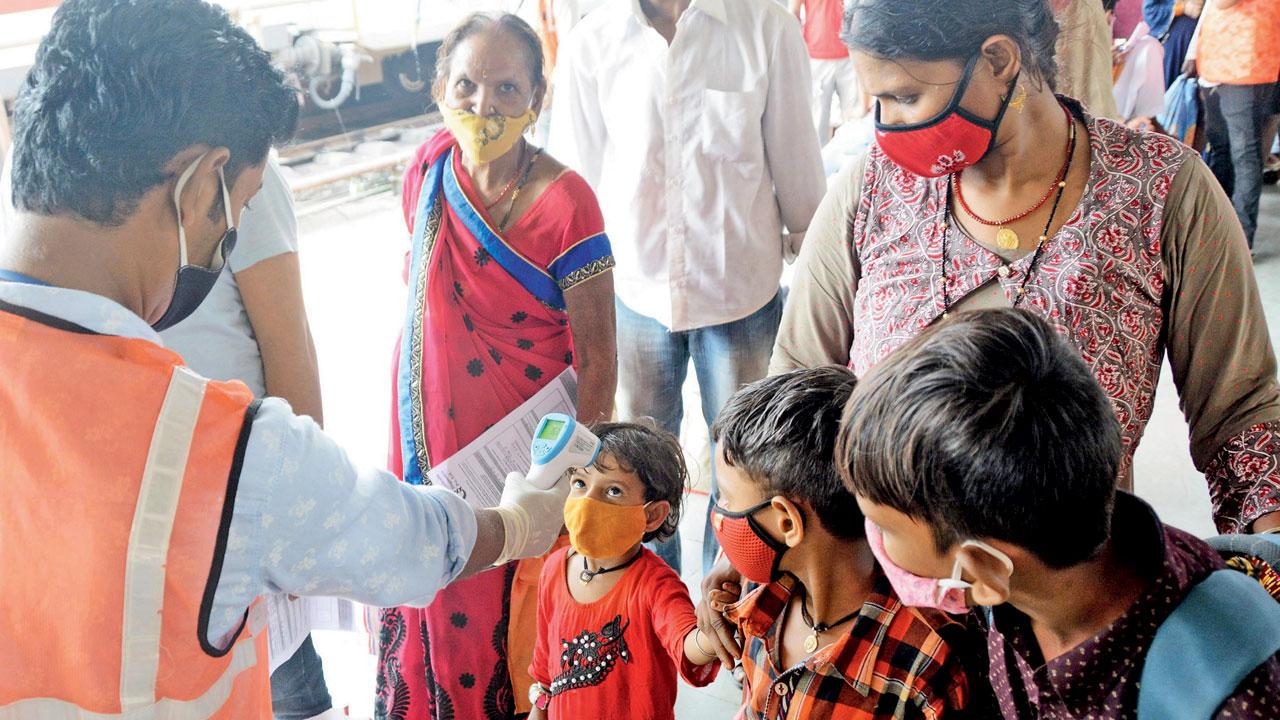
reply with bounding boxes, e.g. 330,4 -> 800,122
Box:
1138,570 -> 1280,720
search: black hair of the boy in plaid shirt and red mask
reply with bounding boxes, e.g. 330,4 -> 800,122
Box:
712,365 -> 864,539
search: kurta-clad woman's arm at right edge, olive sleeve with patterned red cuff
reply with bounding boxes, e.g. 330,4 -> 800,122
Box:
1161,158 -> 1280,532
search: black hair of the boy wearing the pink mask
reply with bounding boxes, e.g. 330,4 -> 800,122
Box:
836,309 -> 1123,568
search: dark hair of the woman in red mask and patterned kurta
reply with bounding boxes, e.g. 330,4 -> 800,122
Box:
840,0 -> 1059,88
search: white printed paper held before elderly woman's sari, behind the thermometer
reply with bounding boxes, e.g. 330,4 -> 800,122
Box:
426,368 -> 577,507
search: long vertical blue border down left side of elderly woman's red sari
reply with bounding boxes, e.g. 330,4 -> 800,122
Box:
396,155 -> 451,486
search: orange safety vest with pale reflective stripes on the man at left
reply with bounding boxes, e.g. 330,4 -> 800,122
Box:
0,304 -> 271,720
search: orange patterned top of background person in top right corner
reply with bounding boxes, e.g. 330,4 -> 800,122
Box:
1197,0 -> 1280,85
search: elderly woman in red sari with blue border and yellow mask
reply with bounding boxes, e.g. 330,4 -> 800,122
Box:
376,14 -> 616,720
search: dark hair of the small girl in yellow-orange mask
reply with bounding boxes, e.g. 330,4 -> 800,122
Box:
591,423 -> 689,542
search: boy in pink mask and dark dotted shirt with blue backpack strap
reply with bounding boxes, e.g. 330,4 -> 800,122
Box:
836,310 -> 1280,720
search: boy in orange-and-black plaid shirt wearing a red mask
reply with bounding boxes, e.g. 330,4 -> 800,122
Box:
709,365 -> 968,720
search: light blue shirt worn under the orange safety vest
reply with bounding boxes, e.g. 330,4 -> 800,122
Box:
0,282 -> 476,647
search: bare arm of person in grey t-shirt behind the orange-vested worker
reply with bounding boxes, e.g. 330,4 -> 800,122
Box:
236,252 -> 324,424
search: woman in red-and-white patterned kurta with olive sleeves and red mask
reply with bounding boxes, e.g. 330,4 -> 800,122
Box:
771,0 -> 1280,532
